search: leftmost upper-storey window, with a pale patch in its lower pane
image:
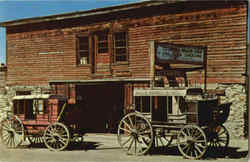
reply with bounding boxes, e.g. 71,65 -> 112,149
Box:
78,36 -> 89,65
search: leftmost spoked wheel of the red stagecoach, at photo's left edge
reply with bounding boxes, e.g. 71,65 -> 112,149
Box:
0,115 -> 24,148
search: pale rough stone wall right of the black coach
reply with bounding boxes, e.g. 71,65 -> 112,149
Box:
217,84 -> 248,138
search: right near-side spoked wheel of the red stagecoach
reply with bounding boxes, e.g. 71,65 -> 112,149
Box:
43,123 -> 70,151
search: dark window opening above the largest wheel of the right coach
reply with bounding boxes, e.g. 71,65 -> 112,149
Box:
135,96 -> 150,112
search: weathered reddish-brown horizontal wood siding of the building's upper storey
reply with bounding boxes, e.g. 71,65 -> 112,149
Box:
7,1 -> 247,85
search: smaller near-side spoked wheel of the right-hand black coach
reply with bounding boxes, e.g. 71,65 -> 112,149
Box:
177,125 -> 207,159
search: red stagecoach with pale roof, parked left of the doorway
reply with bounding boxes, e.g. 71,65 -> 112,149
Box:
1,94 -> 84,151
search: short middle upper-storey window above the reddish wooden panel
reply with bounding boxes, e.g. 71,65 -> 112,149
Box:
97,33 -> 108,53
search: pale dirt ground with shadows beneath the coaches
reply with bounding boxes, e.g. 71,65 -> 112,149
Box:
0,134 -> 248,162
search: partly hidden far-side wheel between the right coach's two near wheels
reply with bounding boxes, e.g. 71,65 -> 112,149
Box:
154,129 -> 173,149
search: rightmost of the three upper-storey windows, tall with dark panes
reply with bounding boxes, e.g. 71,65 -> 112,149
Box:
113,32 -> 128,62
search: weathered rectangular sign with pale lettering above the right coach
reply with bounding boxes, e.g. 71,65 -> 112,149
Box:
155,43 -> 206,65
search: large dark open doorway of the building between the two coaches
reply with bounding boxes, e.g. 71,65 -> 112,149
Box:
76,83 -> 124,133
